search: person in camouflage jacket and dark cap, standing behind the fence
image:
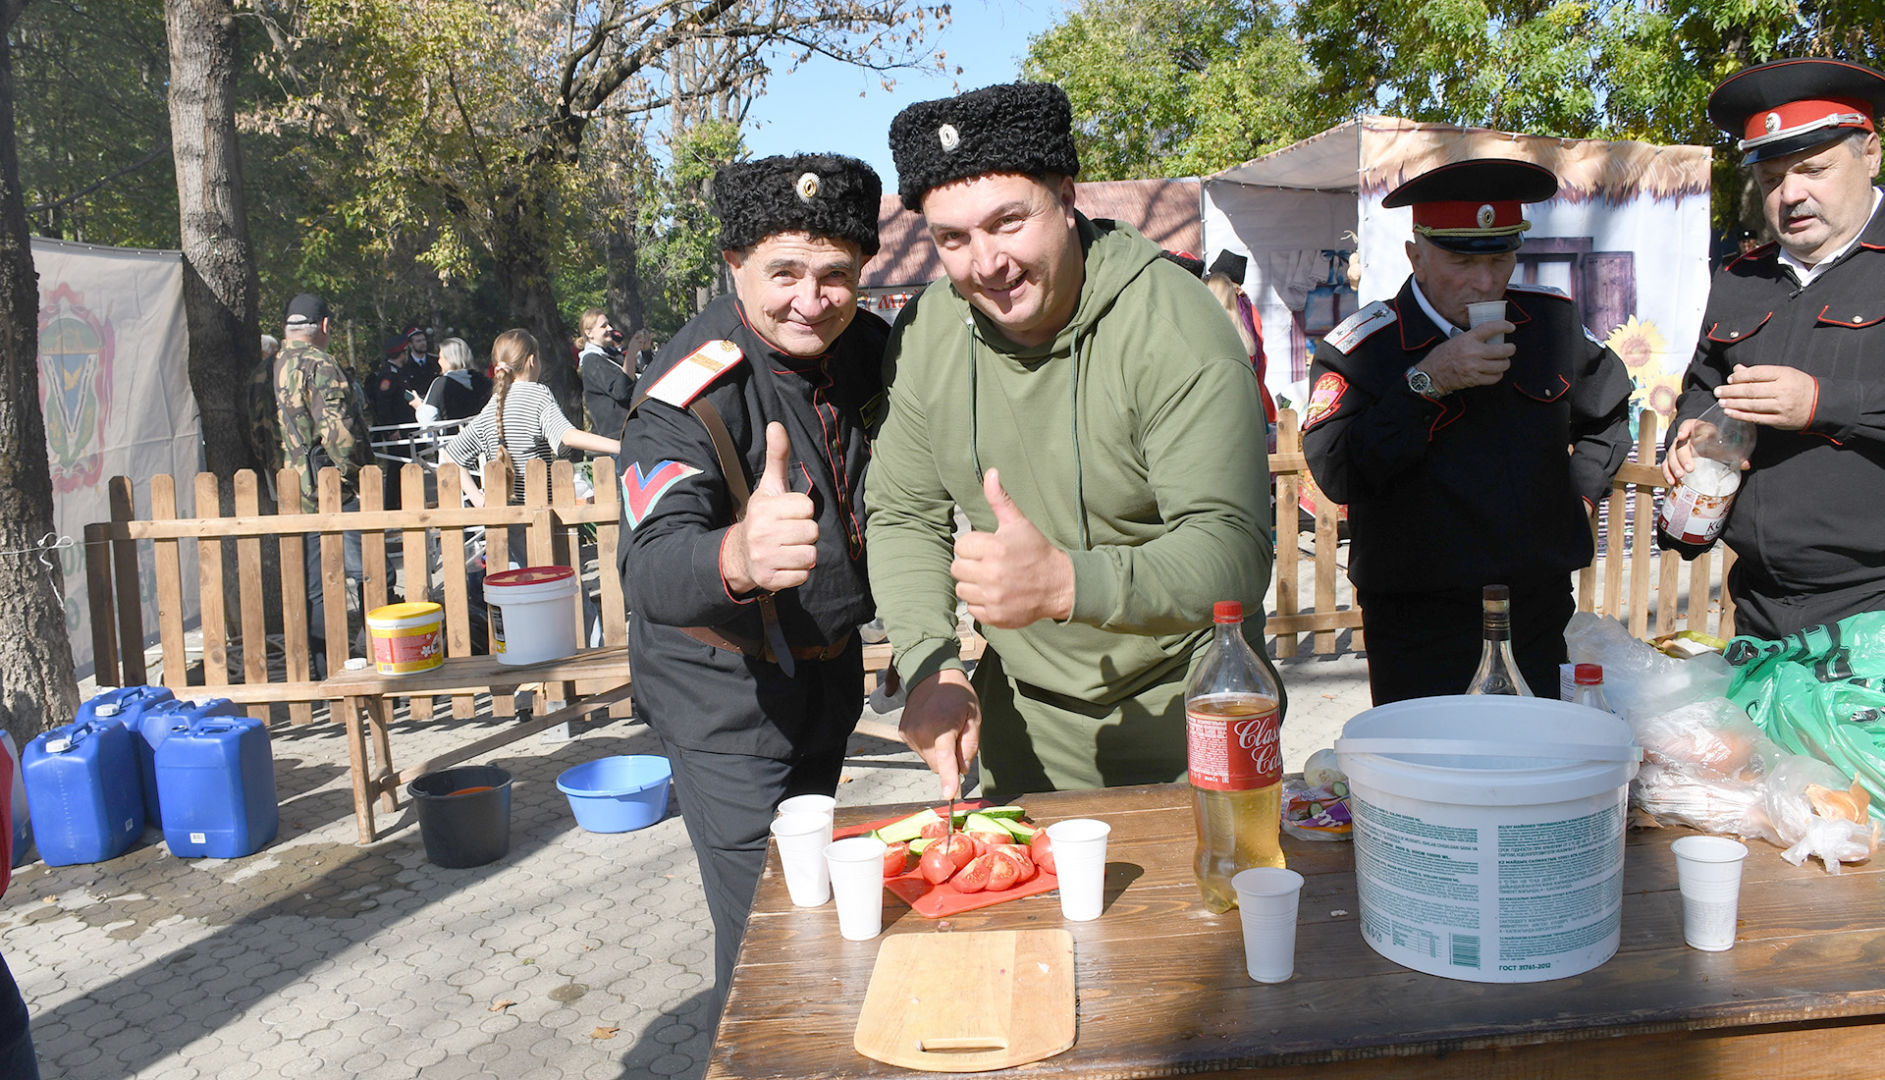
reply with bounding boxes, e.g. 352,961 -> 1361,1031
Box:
249,292 -> 373,659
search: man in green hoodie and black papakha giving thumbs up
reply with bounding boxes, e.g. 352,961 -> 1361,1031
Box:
865,83 -> 1272,797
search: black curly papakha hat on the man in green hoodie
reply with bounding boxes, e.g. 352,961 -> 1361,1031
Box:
890,83 -> 1080,213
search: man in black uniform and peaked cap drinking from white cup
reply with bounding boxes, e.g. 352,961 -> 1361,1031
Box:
1303,160 -> 1631,705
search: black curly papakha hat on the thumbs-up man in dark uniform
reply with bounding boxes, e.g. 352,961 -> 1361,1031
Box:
713,155 -> 884,254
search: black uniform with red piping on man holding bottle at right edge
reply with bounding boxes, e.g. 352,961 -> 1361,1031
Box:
1663,197 -> 1885,639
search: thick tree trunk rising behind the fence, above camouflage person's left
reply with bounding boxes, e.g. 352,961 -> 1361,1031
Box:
164,0 -> 262,480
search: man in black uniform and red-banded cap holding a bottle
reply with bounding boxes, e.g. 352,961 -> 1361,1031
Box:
1663,60 -> 1885,639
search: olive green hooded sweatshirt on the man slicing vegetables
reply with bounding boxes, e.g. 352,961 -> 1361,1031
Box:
865,217 -> 1272,778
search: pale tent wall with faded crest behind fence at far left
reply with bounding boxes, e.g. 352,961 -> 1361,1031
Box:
32,237 -> 202,677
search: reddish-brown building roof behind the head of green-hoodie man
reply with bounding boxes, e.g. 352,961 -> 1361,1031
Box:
863,179 -> 1205,288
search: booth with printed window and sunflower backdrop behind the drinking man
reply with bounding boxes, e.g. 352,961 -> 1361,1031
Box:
1203,117 -> 1710,417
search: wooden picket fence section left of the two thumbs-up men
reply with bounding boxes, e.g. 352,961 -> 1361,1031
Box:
85,458 -> 628,724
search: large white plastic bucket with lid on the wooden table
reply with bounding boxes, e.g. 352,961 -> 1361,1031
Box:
1335,695 -> 1642,982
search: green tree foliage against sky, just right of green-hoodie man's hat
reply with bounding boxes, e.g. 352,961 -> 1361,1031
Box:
1024,0 -> 1316,179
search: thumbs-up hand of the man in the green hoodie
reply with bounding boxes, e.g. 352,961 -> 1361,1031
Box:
948,469 -> 1073,630
